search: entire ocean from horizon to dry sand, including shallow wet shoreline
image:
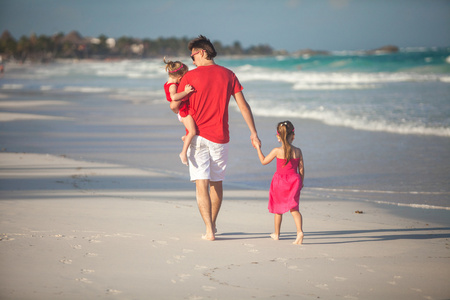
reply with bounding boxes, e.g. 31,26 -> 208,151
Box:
0,48 -> 450,210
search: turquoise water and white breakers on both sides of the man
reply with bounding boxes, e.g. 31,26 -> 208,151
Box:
4,48 -> 450,137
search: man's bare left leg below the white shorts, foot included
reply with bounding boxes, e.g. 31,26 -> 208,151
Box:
195,179 -> 215,241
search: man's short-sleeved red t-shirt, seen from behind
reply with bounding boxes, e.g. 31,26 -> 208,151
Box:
178,65 -> 243,144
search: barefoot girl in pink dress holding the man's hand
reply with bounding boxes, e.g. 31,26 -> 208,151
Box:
256,121 -> 305,244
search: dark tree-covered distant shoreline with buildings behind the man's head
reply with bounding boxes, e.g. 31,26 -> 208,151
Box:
0,30 -> 275,62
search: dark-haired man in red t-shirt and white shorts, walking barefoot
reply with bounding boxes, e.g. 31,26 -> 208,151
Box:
171,35 -> 261,241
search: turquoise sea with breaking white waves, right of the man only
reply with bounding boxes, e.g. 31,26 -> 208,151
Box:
218,49 -> 450,137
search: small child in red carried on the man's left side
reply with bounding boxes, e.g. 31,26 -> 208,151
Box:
164,57 -> 196,165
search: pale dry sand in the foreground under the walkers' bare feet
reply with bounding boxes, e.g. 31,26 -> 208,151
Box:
0,153 -> 450,299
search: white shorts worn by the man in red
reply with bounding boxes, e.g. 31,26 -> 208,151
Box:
188,135 -> 228,181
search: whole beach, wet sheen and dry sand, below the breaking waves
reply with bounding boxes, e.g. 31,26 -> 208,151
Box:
0,80 -> 450,299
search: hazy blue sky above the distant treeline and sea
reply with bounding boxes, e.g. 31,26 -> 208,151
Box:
0,0 -> 450,51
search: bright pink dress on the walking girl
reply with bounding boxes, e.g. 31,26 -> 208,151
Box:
268,158 -> 302,214
